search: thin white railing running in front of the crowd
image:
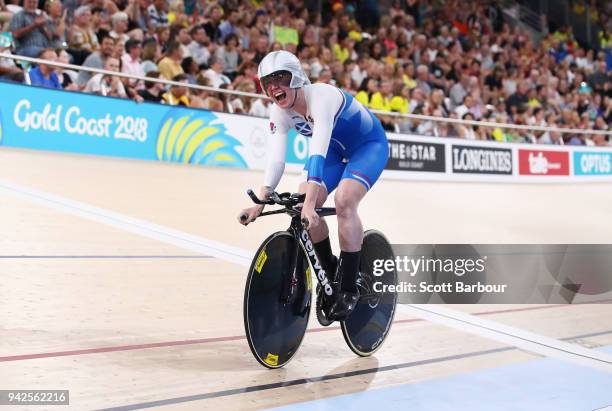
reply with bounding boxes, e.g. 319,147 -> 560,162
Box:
0,53 -> 612,136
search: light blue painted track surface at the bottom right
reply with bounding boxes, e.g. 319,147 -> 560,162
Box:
275,346 -> 612,411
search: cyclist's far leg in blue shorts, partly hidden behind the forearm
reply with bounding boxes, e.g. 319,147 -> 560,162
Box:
299,149 -> 345,276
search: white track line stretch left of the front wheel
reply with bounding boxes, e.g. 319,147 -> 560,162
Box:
0,180 -> 253,267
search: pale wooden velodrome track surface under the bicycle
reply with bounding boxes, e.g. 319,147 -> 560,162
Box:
0,149 -> 612,410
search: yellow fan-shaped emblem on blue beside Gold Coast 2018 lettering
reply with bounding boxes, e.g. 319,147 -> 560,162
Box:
157,109 -> 247,168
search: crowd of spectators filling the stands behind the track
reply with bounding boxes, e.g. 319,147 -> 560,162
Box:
0,0 -> 612,145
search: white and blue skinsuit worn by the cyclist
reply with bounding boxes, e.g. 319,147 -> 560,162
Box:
264,83 -> 389,193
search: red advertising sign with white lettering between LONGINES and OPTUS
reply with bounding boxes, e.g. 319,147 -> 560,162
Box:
519,150 -> 570,176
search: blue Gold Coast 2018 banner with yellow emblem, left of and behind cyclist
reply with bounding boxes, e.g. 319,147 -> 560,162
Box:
0,83 -> 314,168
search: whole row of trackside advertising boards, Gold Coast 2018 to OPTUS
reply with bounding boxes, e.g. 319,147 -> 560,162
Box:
0,83 -> 612,182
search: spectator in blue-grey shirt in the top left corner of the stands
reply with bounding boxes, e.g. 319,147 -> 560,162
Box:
9,0 -> 53,57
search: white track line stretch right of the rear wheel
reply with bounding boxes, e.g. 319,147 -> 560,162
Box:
398,304 -> 612,372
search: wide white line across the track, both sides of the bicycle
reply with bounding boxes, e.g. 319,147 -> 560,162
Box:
0,180 -> 612,371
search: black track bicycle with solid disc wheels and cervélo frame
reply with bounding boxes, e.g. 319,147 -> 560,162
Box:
244,190 -> 397,368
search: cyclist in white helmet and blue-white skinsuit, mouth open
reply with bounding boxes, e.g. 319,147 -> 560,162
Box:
238,51 -> 389,321
